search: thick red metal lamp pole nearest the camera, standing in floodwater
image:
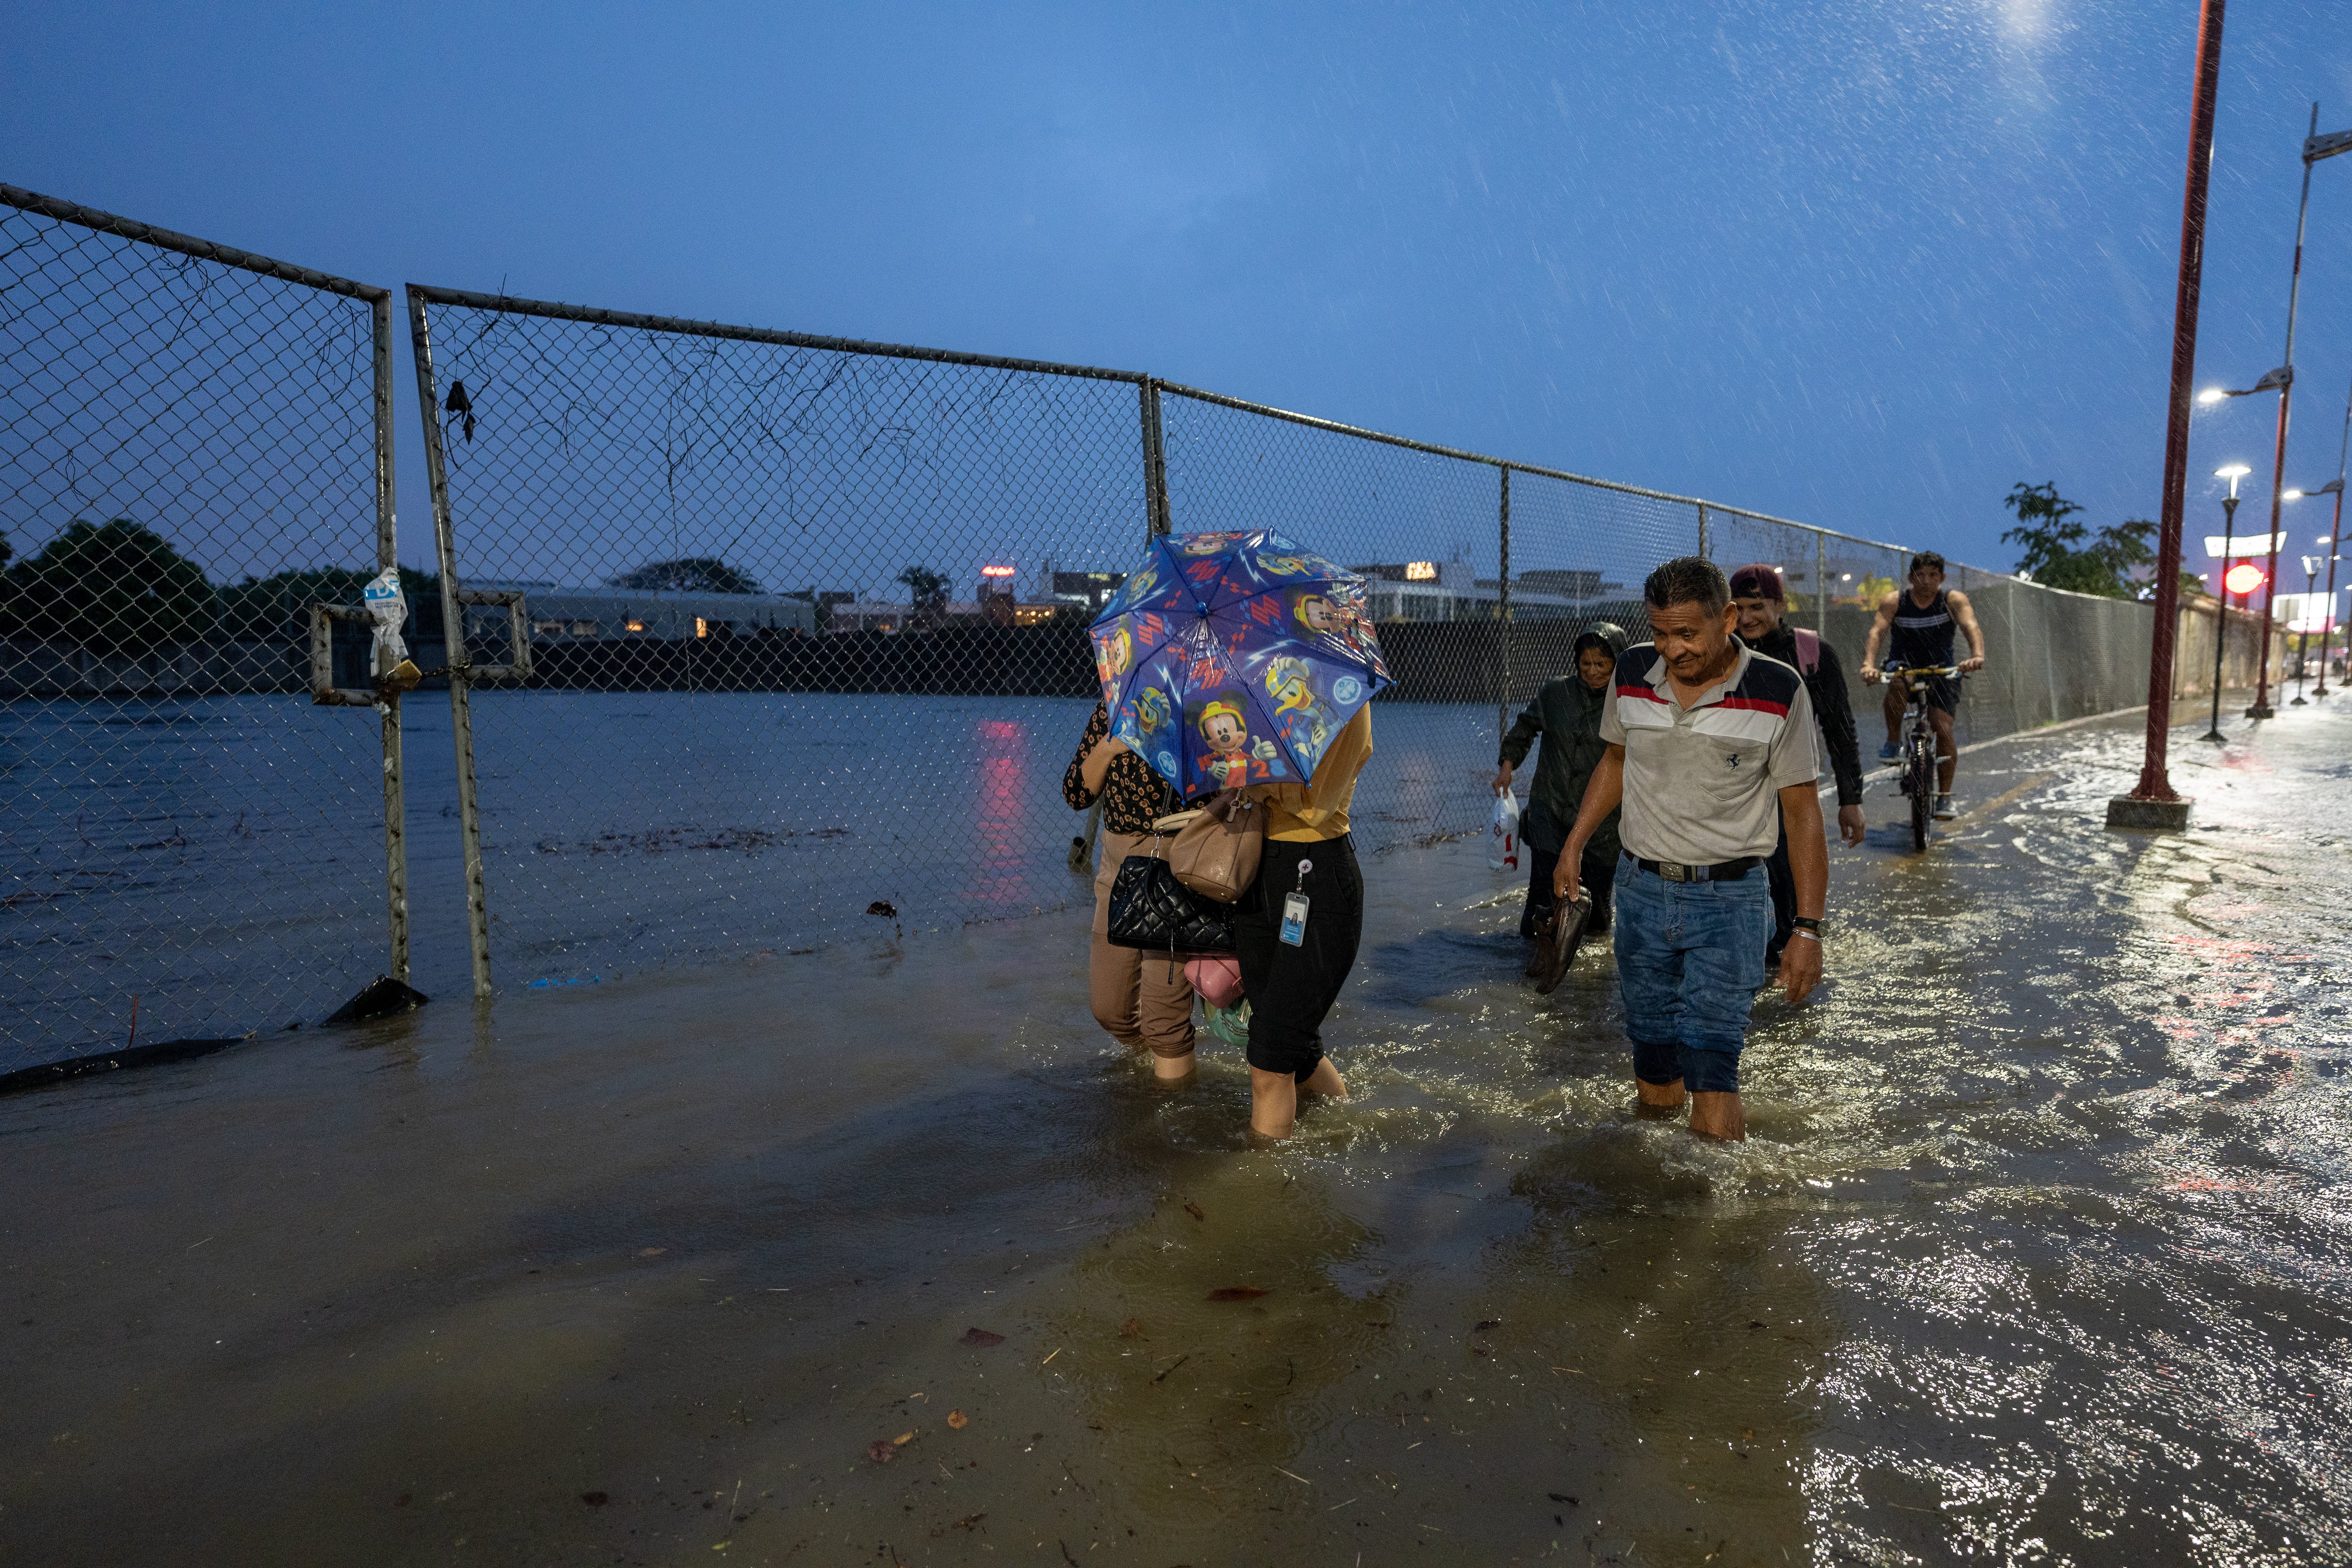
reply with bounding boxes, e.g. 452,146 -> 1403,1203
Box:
2131,0 -> 2227,802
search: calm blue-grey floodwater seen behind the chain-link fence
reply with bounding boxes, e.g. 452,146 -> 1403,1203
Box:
0,691 -> 1498,1072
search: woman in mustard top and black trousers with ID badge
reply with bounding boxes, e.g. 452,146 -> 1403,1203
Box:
1232,708 -> 1371,1138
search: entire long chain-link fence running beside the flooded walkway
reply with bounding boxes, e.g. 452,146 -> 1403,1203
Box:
0,177 -> 2201,1034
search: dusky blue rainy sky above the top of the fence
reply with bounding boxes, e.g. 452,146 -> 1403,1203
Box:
0,0 -> 2352,581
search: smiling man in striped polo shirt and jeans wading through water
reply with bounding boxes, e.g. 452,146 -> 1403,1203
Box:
1552,555 -> 1830,1140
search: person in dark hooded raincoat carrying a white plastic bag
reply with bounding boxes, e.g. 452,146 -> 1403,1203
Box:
1494,621 -> 1625,936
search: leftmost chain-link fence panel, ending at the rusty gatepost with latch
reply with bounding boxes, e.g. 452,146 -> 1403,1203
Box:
0,186 -> 407,1072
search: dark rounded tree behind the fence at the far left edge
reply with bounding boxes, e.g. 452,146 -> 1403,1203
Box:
9,517 -> 219,653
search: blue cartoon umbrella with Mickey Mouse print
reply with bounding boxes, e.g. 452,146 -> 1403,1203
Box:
1089,529 -> 1390,797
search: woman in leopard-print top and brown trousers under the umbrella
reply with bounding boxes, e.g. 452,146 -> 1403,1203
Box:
1061,703 -> 1192,1079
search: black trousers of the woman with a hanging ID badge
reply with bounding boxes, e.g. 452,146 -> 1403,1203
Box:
1232,839 -> 1364,1084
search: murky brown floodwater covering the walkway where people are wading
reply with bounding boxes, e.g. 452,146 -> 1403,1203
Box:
0,698 -> 2352,1568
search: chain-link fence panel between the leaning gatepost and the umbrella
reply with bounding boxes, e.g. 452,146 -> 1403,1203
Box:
407,285 -> 1152,995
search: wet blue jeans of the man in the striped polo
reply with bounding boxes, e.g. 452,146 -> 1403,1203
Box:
1616,856 -> 1771,1093
